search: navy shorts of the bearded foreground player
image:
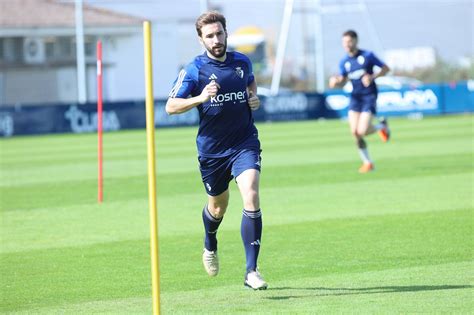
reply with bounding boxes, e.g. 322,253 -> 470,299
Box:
198,149 -> 262,196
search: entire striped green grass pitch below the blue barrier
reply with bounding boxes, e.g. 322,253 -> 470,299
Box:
0,115 -> 474,314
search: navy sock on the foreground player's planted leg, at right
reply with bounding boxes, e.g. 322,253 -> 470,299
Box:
240,209 -> 262,272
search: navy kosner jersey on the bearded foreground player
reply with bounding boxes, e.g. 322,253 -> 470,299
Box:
169,52 -> 260,157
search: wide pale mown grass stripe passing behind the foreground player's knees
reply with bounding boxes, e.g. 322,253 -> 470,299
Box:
0,170 -> 473,252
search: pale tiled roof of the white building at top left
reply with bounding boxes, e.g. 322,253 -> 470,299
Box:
0,0 -> 143,29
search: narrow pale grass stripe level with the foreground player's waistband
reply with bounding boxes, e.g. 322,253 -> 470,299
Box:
0,133 -> 473,186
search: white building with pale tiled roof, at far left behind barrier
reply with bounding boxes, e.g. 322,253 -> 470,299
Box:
0,0 -> 147,104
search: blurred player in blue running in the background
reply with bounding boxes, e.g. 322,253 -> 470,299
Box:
329,30 -> 390,173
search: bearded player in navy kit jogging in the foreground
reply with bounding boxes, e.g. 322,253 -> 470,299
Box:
166,11 -> 267,290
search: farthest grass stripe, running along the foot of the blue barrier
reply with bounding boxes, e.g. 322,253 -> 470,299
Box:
0,116 -> 473,162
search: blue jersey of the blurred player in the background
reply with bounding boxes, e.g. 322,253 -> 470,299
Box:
339,49 -> 385,95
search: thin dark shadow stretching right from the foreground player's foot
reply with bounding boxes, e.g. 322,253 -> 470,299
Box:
266,285 -> 474,300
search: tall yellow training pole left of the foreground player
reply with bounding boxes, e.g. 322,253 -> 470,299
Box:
143,21 -> 160,314
